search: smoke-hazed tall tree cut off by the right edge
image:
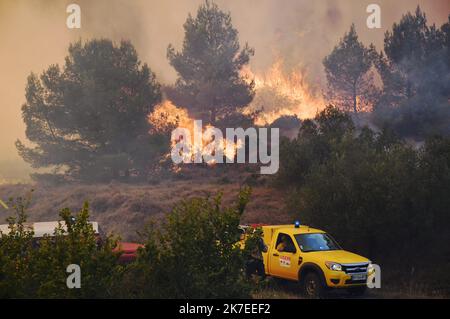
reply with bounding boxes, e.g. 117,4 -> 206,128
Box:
375,7 -> 450,137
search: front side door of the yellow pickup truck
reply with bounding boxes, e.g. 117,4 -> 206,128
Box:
269,233 -> 299,280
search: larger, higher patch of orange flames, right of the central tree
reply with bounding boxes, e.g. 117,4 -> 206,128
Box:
242,59 -> 325,125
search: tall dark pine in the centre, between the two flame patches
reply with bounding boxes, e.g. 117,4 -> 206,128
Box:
167,1 -> 254,124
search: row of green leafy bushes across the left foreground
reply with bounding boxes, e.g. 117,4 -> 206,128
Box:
0,188 -> 258,298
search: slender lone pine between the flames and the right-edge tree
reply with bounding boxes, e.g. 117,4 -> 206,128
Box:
323,25 -> 377,113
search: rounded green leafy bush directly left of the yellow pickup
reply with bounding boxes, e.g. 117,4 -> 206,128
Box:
127,189 -> 250,298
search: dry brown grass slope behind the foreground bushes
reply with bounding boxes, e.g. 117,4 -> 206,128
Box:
0,180 -> 290,240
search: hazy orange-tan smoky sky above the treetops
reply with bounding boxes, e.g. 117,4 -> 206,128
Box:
0,0 -> 450,170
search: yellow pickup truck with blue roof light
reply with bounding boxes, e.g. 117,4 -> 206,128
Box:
243,222 -> 373,298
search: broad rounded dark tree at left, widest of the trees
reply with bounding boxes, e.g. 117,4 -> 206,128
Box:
16,39 -> 167,180
